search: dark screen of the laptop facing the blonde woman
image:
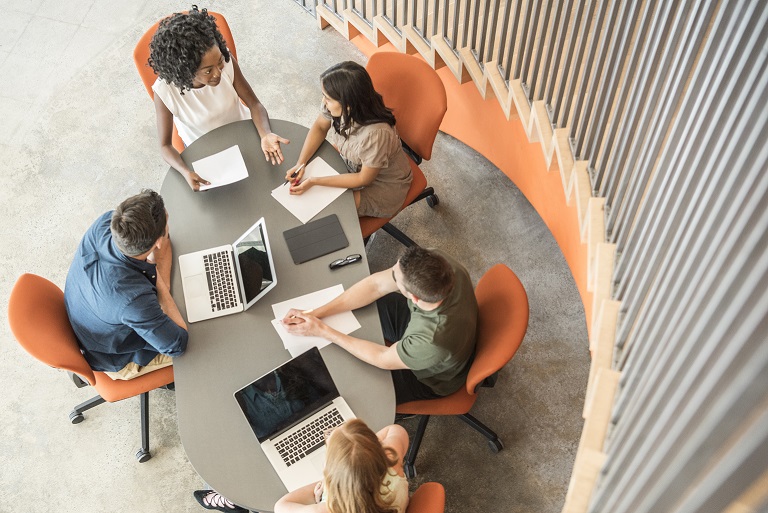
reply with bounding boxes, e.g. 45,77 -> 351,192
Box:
235,347 -> 339,443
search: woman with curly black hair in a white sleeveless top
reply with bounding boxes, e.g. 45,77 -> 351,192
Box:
148,5 -> 288,191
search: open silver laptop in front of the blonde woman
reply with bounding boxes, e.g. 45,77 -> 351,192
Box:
234,347 -> 355,491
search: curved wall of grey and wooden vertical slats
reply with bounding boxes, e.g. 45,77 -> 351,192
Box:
300,0 -> 768,513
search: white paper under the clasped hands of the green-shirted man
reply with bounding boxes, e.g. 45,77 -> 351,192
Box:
272,284 -> 360,357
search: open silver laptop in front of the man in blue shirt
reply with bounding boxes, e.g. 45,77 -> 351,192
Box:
179,217 -> 277,322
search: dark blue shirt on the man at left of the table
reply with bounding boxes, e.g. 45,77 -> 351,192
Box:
64,212 -> 189,372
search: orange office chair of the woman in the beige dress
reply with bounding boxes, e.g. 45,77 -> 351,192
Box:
360,52 -> 448,246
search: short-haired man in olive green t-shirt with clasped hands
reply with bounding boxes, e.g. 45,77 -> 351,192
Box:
282,246 -> 477,404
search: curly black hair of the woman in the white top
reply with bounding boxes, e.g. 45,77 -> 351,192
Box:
147,5 -> 229,94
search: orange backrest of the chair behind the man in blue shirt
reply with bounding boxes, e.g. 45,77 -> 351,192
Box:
8,274 -> 96,385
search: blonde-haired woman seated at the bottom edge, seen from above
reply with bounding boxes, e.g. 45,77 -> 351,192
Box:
275,419 -> 408,513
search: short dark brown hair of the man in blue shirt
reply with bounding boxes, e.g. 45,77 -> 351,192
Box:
109,189 -> 167,257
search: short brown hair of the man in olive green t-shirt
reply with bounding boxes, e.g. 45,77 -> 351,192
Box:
398,246 -> 454,303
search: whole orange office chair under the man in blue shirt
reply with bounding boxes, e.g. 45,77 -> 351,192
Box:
8,274 -> 173,463
